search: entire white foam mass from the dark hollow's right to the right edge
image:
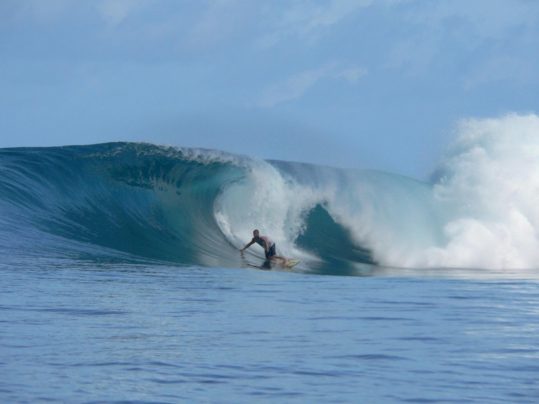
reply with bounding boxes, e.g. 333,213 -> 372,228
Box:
330,114 -> 539,269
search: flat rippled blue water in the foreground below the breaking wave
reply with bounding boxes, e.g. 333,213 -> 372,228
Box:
0,260 -> 539,403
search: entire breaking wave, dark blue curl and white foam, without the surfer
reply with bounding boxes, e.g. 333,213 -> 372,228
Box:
0,115 -> 539,273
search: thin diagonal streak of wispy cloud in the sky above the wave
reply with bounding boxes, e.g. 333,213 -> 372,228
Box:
258,63 -> 367,108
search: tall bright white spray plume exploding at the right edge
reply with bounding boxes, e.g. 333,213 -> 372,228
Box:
416,114 -> 539,269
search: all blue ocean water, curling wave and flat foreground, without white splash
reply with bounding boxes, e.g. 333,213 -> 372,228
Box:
0,144 -> 539,403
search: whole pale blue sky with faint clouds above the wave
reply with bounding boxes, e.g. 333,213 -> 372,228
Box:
0,0 -> 539,178
